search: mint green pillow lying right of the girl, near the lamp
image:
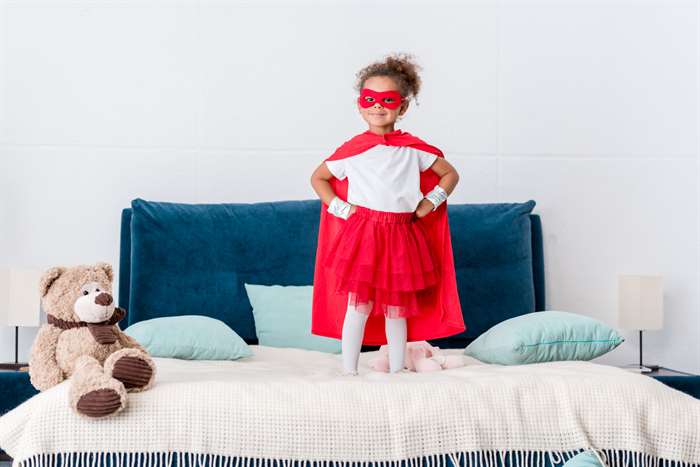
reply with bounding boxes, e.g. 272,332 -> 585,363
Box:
464,311 -> 625,365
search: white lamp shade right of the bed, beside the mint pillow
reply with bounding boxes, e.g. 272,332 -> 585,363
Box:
617,274 -> 664,330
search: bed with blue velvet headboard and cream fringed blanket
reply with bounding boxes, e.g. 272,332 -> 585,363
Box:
0,200 -> 700,467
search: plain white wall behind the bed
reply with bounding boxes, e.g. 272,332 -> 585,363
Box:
0,0 -> 700,372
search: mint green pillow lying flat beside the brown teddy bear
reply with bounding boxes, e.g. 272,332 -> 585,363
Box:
124,315 -> 253,360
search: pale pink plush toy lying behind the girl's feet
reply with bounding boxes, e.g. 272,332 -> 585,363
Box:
369,341 -> 464,373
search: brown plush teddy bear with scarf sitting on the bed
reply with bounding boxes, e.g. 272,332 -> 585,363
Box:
29,263 -> 156,418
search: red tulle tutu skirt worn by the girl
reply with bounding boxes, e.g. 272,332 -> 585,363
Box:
324,206 -> 439,318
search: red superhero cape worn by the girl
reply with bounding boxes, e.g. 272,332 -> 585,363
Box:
311,130 -> 466,345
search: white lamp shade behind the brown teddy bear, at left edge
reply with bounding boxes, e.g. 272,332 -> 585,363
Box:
0,269 -> 42,327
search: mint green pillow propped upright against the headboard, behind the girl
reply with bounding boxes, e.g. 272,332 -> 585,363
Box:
243,283 -> 340,353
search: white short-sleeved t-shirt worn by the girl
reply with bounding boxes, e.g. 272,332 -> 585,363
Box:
326,144 -> 438,212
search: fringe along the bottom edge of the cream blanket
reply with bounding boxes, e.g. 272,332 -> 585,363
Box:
12,448 -> 700,467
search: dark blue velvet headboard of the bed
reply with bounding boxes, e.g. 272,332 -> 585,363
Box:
119,199 -> 545,348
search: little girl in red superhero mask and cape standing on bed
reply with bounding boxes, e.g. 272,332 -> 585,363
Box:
311,54 -> 465,375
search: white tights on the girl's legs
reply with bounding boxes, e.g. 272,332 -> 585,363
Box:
341,302 -> 406,374
